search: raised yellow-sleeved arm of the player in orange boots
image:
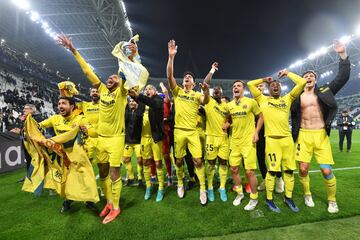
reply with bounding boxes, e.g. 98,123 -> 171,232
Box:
58,33 -> 101,88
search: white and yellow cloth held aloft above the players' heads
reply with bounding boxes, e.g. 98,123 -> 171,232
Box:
112,35 -> 149,90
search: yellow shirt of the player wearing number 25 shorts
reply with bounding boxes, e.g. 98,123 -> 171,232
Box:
204,97 -> 228,137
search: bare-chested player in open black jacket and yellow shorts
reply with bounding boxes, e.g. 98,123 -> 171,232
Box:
291,41 -> 350,213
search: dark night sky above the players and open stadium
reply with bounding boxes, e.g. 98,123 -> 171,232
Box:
125,0 -> 360,79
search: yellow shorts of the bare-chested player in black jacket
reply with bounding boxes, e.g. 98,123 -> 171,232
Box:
295,128 -> 334,165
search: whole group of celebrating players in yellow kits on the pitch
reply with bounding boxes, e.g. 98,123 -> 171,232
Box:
22,31 -> 350,224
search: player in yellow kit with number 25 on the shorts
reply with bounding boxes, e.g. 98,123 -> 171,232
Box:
204,86 -> 229,202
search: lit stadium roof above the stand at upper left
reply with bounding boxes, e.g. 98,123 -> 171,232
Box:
0,0 -> 132,85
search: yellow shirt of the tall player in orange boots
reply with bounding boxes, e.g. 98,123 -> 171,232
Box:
98,83 -> 127,137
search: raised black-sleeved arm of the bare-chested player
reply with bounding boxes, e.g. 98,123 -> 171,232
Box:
329,41 -> 350,95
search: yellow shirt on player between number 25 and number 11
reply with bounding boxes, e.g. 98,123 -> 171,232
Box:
227,97 -> 260,139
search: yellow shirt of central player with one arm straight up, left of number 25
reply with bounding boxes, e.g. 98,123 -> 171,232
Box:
171,86 -> 201,130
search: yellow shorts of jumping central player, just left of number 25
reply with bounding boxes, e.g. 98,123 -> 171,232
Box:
174,128 -> 202,158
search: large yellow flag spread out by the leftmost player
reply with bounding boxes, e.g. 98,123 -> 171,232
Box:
23,115 -> 99,202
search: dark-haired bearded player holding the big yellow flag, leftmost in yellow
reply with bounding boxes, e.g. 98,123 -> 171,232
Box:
39,97 -> 97,212
